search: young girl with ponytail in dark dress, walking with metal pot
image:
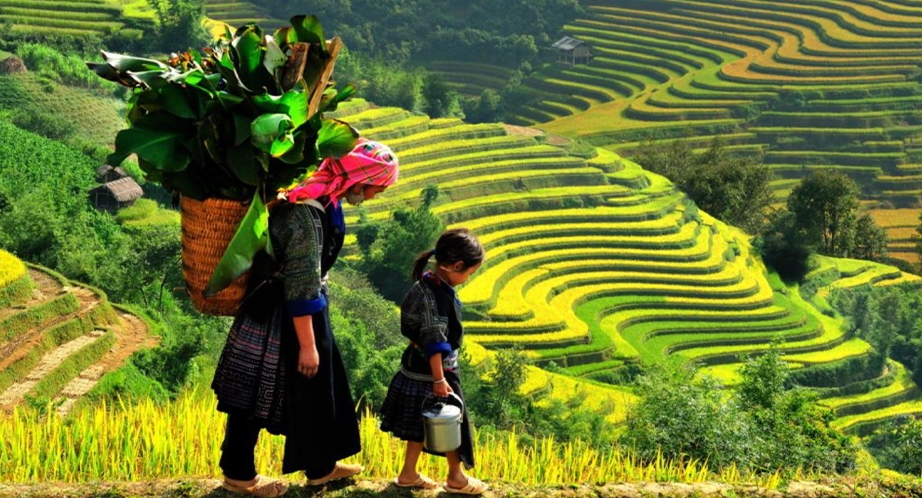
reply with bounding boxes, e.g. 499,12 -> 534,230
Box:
381,228 -> 486,495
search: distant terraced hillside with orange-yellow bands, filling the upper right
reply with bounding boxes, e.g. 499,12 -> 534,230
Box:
464,0 -> 922,262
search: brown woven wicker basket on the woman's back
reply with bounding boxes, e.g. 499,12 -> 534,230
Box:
181,197 -> 250,316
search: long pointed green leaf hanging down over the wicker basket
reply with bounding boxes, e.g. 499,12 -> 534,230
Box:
205,191 -> 269,297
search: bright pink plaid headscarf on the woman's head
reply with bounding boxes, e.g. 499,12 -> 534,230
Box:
287,138 -> 397,205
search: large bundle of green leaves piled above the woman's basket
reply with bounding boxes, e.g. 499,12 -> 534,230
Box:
88,16 -> 358,295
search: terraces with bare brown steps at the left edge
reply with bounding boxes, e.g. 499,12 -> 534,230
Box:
0,250 -> 156,414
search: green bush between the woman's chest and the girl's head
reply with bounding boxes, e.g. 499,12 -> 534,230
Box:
356,188 -> 443,301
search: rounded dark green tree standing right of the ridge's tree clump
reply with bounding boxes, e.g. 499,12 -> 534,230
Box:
788,170 -> 859,256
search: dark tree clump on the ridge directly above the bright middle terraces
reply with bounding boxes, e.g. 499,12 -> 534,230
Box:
635,138 -> 773,233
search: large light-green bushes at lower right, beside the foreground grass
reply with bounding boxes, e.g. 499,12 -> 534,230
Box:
622,345 -> 856,474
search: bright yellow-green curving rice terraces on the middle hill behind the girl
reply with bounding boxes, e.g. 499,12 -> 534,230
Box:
328,100 -> 922,431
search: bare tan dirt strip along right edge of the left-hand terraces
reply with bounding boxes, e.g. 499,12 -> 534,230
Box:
56,312 -> 159,415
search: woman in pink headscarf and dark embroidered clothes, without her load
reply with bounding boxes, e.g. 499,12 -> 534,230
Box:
212,140 -> 397,497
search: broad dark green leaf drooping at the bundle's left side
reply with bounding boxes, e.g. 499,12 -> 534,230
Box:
107,127 -> 189,172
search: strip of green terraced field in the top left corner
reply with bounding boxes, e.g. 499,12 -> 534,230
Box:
0,0 -> 154,39
